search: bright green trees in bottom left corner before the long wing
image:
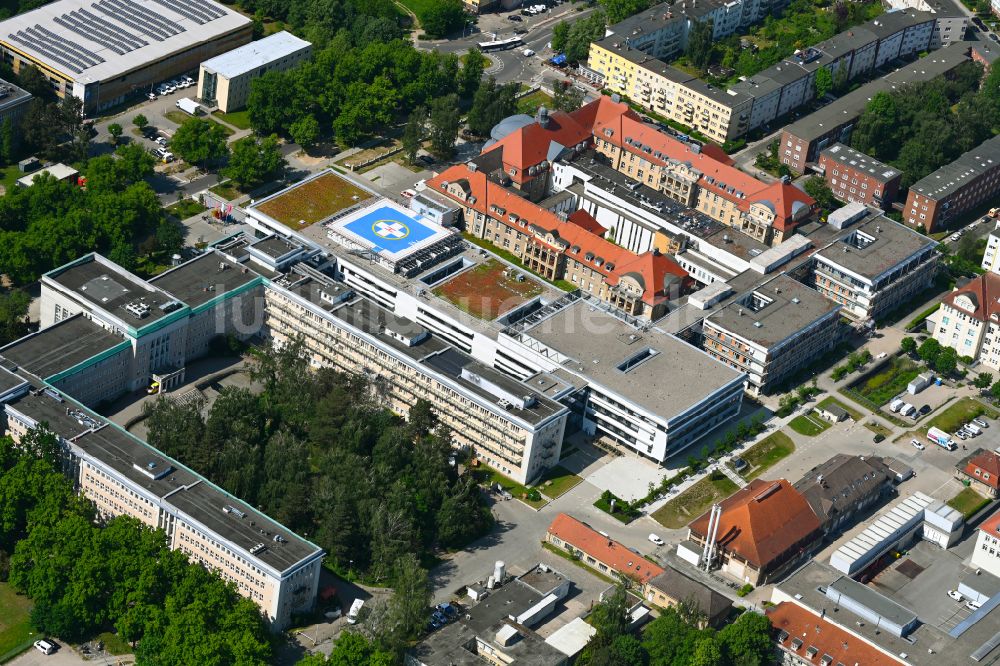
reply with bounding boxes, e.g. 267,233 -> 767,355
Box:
0,430 -> 271,666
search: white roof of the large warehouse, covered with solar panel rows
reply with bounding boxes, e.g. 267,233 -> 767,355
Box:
0,0 -> 250,83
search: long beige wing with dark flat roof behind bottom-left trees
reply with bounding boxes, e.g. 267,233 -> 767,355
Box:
0,370 -> 323,631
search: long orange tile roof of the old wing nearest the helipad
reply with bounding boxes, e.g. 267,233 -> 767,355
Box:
427,164 -> 688,305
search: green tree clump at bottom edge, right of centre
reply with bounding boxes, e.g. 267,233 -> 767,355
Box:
576,585 -> 774,666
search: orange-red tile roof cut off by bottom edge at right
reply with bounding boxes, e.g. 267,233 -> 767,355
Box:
767,601 -> 906,666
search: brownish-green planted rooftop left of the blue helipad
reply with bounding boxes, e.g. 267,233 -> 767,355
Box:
254,172 -> 372,229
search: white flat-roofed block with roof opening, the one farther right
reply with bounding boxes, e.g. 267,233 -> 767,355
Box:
813,215 -> 938,321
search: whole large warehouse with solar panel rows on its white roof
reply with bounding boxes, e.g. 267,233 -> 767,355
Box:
0,0 -> 251,114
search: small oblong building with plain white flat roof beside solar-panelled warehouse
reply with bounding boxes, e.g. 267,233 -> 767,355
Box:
198,30 -> 312,113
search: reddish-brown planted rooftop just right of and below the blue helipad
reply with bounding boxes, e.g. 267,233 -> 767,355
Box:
434,259 -> 543,321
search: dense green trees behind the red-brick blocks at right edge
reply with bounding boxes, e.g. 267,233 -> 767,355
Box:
851,62 -> 1000,187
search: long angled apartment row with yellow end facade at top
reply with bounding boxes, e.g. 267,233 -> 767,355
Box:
587,2 -> 944,143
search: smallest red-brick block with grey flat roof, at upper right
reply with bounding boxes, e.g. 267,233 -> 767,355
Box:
819,143 -> 903,210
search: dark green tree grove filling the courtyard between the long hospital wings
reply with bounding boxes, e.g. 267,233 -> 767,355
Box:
147,342 -> 492,582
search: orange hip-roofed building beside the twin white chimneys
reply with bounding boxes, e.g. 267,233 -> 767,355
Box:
690,479 -> 820,570
